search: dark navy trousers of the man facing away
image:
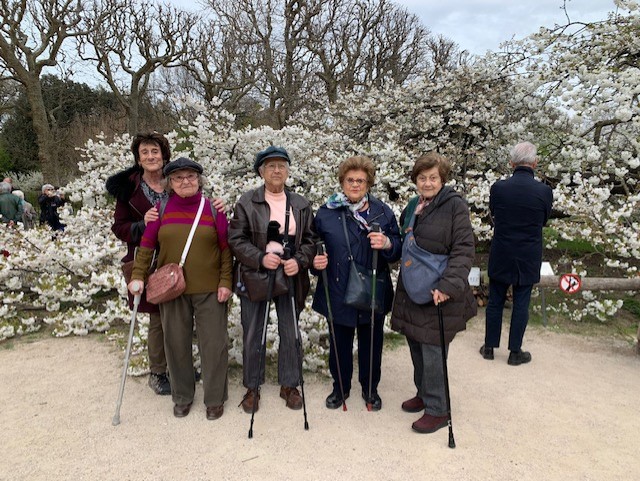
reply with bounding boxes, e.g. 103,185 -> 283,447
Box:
484,279 -> 533,351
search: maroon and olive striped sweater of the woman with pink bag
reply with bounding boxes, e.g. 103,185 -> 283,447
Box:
131,192 -> 233,294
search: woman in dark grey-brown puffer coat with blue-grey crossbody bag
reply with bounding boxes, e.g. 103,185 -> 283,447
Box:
391,152 -> 477,433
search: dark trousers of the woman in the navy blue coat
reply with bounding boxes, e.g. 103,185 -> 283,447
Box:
329,320 -> 384,394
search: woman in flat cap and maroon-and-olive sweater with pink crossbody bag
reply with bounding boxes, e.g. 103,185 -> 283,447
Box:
128,157 -> 233,420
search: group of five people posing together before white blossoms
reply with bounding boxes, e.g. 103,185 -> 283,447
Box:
108,134 -> 536,433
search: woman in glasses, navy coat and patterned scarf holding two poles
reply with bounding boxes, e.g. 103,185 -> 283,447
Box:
313,156 -> 402,410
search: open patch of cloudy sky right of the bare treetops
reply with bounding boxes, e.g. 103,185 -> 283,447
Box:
395,0 -> 615,55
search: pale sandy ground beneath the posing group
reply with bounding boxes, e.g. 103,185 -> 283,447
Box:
0,318 -> 640,480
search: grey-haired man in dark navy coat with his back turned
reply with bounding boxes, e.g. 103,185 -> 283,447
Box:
480,142 -> 553,366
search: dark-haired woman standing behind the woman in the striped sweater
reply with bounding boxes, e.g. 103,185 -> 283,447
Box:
106,132 -> 171,395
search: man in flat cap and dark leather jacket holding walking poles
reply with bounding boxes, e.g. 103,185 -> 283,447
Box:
229,146 -> 317,413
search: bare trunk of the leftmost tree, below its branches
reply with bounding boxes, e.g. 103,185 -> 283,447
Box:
25,78 -> 60,186
